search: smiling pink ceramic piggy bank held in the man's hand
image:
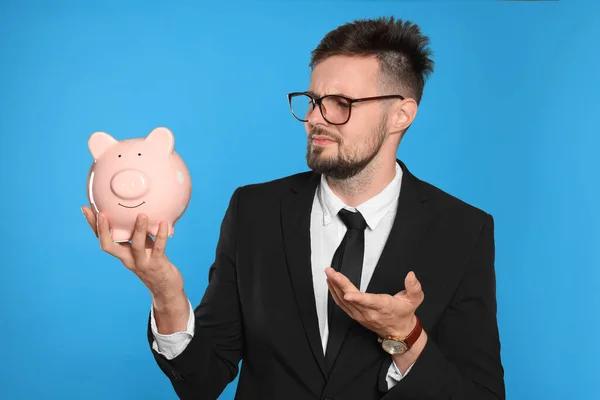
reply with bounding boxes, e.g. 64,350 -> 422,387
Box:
87,127 -> 192,242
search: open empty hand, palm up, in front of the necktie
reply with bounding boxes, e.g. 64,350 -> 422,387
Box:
325,268 -> 425,338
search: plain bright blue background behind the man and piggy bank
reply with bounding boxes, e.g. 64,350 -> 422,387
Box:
0,0 -> 600,400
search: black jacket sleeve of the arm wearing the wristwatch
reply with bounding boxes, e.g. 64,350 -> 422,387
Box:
382,214 -> 506,400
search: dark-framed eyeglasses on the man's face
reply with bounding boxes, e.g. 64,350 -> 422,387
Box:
287,92 -> 404,125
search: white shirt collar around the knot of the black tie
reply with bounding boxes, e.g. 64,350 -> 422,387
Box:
317,163 -> 402,229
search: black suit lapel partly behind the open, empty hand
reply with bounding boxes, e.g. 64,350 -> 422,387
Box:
328,161 -> 432,393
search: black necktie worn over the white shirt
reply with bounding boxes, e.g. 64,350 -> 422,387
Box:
325,209 -> 367,364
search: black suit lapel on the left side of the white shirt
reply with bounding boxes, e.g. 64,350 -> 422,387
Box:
281,174 -> 326,379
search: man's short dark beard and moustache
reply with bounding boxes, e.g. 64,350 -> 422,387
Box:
306,118 -> 385,180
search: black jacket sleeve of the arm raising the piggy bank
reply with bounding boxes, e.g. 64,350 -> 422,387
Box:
148,188 -> 244,400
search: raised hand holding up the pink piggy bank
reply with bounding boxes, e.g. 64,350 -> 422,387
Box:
81,207 -> 183,306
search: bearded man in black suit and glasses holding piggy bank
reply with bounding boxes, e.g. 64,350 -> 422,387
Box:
84,18 -> 505,400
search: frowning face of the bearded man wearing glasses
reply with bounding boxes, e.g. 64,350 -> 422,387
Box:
305,56 -> 387,179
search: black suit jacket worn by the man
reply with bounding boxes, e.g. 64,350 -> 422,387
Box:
148,161 -> 505,400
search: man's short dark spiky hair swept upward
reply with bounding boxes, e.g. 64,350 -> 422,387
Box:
309,17 -> 434,103
